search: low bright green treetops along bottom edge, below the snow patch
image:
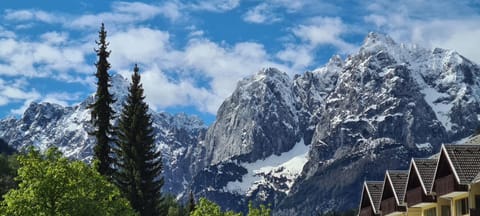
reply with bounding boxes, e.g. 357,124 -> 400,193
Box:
190,198 -> 272,216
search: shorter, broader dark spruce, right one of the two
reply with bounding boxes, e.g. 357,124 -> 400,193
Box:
115,64 -> 163,216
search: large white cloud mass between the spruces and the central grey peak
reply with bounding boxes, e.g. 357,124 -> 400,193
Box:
110,28 -> 287,114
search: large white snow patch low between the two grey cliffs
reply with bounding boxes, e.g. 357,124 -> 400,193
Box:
224,140 -> 309,195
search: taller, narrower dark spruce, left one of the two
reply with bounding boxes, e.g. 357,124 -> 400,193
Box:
89,23 -> 115,178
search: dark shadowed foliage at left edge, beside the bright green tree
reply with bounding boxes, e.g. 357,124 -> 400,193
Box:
0,154 -> 19,201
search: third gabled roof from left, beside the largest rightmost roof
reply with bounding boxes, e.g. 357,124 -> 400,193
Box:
409,158 -> 437,194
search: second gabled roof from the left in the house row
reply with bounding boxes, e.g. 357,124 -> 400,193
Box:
382,170 -> 408,205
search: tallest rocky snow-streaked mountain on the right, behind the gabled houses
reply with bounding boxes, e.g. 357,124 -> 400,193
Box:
276,33 -> 480,215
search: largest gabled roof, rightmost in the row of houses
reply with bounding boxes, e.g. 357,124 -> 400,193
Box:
432,145 -> 480,187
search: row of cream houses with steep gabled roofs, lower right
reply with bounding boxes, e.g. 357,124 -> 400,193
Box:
359,145 -> 480,216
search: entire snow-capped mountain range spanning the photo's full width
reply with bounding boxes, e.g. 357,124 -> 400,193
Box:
0,33 -> 480,215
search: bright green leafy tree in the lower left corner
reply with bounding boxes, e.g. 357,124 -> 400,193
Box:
0,148 -> 135,216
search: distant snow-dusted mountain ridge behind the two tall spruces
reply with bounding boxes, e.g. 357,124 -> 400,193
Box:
0,75 -> 207,194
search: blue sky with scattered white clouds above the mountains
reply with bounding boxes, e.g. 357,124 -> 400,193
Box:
0,0 -> 480,124
